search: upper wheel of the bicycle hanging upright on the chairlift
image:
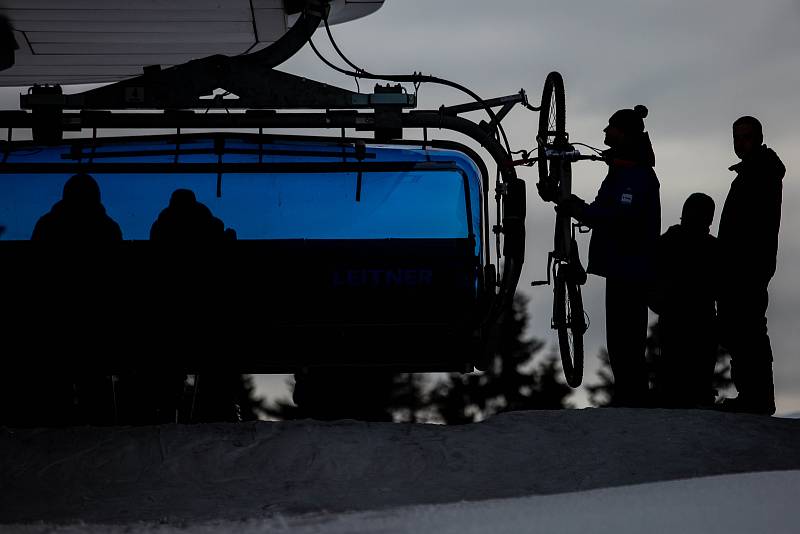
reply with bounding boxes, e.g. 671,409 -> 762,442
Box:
536,71 -> 567,182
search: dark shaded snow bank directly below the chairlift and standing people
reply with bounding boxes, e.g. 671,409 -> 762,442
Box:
0,409 -> 800,524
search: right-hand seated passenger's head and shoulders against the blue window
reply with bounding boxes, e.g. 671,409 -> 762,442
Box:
150,189 -> 226,243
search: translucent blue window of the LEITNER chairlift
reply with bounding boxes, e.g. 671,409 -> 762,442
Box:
0,138 -> 483,249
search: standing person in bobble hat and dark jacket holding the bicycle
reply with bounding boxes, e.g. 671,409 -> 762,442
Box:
557,106 -> 661,406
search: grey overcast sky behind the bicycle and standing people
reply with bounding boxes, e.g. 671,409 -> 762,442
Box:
270,0 -> 800,413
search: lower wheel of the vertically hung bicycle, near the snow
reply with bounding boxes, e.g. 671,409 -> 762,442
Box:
553,265 -> 586,388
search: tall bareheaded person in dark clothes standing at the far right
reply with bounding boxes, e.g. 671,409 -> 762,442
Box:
719,116 -> 786,415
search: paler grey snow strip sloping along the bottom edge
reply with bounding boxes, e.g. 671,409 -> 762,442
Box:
13,471 -> 800,534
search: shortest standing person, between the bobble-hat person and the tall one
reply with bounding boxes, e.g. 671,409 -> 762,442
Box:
650,193 -> 719,408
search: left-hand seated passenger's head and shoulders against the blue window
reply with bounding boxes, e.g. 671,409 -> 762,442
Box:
31,173 -> 122,243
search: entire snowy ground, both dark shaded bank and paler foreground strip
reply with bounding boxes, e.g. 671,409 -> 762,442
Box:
0,409 -> 800,534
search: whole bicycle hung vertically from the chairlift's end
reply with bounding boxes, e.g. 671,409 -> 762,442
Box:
526,72 -> 603,388
